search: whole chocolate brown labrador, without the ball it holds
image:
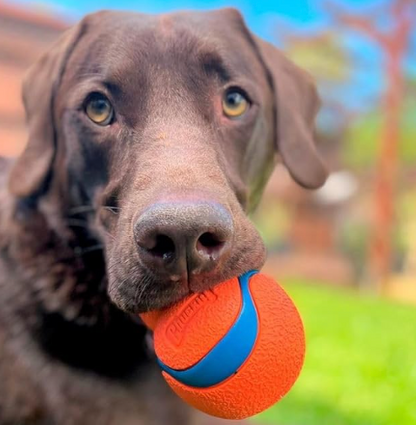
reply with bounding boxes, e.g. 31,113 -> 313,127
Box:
0,9 -> 326,425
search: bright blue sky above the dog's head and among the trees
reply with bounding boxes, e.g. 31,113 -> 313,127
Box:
9,0 -> 416,110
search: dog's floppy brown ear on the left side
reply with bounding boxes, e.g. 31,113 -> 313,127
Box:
9,24 -> 82,198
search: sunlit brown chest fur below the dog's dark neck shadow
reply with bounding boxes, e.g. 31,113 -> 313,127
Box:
0,270 -> 188,425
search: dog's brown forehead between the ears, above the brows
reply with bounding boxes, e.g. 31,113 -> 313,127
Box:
71,10 -> 261,82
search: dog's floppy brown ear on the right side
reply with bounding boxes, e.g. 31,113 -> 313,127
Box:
255,37 -> 327,189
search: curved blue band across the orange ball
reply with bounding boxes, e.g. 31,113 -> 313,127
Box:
158,270 -> 259,388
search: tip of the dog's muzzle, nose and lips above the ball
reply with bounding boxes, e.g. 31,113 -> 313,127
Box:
106,194 -> 265,314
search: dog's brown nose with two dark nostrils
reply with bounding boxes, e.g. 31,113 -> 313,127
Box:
134,201 -> 233,279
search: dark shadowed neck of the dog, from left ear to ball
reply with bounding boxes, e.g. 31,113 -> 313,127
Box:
0,176 -> 147,378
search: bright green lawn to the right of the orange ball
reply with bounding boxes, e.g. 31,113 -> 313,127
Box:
255,282 -> 416,425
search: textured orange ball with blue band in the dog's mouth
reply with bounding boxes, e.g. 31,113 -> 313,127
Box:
141,271 -> 305,419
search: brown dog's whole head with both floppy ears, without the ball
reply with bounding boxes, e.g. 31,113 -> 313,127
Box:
10,10 -> 325,312
